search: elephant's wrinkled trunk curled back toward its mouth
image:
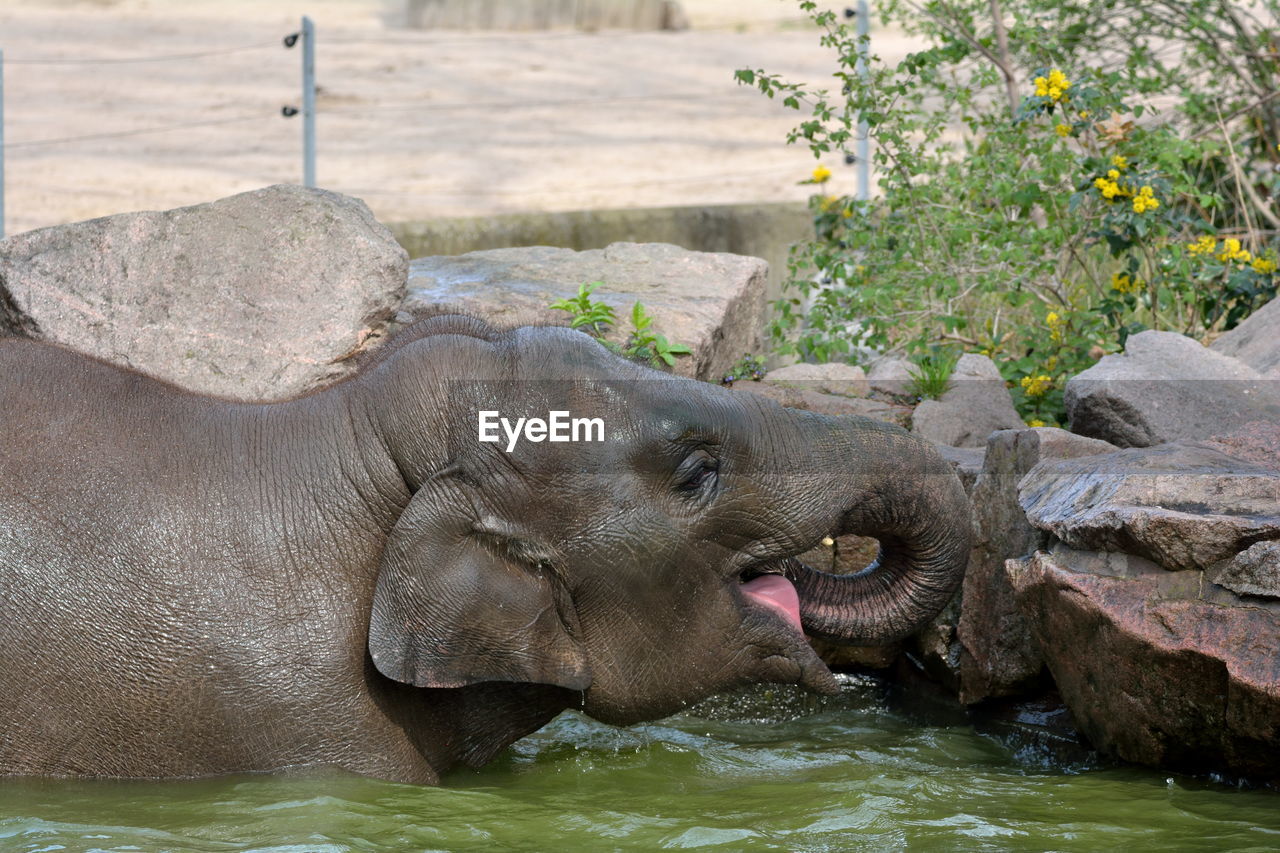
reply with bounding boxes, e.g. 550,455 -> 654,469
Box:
786,414 -> 970,646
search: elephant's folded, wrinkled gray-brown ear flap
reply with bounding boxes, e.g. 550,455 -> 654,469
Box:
369,487 -> 591,690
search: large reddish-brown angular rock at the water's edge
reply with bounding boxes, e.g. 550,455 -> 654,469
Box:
1009,548 -> 1280,781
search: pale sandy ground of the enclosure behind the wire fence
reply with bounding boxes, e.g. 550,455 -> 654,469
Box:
0,0 -> 909,234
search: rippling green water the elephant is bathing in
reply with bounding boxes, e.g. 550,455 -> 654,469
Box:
0,678 -> 1280,853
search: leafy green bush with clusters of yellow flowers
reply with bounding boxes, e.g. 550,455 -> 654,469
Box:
736,0 -> 1280,424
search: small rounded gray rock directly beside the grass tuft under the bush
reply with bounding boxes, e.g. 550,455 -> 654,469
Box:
911,353 -> 1025,447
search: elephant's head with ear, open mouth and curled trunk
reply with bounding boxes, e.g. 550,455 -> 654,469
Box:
364,318 -> 969,724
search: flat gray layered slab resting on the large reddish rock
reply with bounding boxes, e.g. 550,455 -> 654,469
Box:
1018,442 -> 1280,570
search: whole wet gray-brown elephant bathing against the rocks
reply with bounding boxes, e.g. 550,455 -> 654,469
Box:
0,318 -> 968,783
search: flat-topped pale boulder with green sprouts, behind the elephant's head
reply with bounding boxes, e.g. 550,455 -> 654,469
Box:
404,243 -> 768,380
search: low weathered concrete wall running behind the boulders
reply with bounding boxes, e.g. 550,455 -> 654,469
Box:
389,202 -> 813,300
